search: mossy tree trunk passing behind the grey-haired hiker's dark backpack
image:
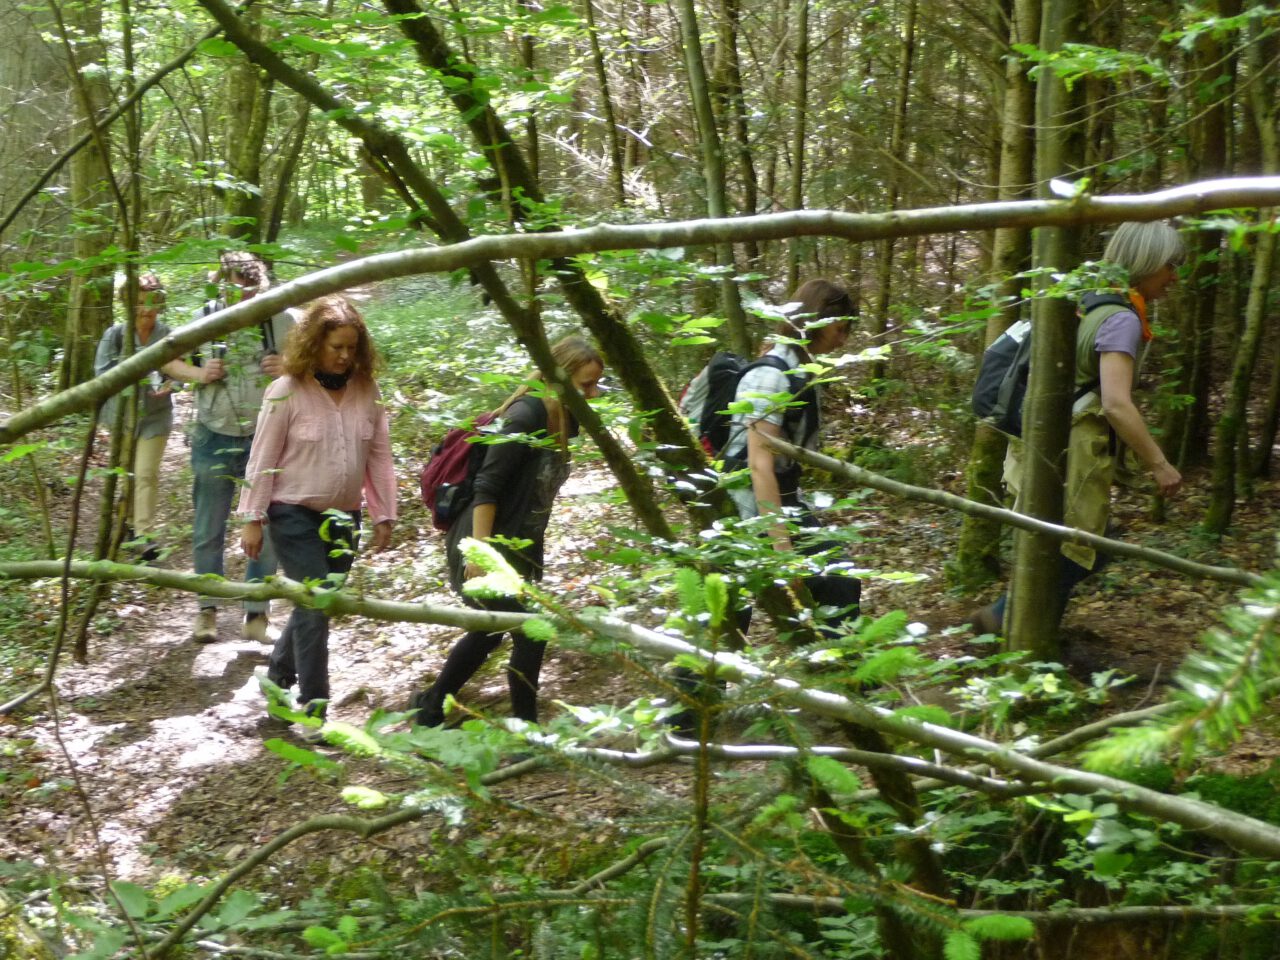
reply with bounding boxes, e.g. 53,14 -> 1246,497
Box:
947,0 -> 1041,590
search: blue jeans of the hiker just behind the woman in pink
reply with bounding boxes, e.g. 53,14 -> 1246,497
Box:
191,422 -> 276,613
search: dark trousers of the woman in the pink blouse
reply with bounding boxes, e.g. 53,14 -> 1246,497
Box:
266,503 -> 360,704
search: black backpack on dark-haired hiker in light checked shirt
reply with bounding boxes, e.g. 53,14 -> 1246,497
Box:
680,349 -> 818,457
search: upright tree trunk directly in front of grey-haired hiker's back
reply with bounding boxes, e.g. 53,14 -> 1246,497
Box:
1009,0 -> 1084,660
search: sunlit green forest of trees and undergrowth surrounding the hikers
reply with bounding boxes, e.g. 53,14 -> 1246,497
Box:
0,0 -> 1280,960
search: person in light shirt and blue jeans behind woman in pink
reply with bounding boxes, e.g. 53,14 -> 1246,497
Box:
191,251 -> 294,644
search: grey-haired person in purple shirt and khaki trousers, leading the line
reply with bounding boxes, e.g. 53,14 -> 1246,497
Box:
970,221 -> 1187,634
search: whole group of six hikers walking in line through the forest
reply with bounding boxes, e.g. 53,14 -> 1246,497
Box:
96,223 -> 1184,740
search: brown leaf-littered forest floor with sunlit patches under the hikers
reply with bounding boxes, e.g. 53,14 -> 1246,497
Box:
0,386 -> 1280,926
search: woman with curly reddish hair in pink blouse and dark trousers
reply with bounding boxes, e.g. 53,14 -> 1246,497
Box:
239,296 -> 396,740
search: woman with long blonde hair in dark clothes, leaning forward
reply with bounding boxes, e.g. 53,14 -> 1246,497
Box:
410,337 -> 604,727
